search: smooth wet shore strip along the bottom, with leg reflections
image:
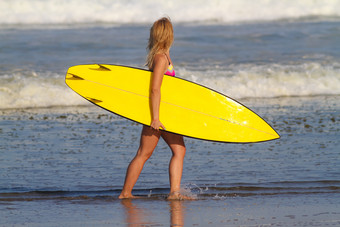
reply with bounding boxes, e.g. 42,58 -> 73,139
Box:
0,194 -> 340,226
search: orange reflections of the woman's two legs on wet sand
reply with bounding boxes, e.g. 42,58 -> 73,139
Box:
121,199 -> 184,227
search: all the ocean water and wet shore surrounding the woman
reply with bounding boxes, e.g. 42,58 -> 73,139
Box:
0,0 -> 340,226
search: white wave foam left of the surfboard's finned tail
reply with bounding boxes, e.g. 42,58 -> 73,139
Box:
0,72 -> 88,109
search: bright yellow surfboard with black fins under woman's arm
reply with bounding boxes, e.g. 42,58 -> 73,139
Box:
65,64 -> 280,143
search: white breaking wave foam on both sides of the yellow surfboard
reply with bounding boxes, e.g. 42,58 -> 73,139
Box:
0,63 -> 340,109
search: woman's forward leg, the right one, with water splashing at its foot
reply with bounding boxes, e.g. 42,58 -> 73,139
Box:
162,131 -> 186,199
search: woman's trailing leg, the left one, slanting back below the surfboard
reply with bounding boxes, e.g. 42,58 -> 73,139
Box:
119,126 -> 161,199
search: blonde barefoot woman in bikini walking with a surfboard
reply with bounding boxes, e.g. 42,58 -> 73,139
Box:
119,18 -> 188,199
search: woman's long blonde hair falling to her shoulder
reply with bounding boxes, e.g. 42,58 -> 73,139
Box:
146,17 -> 174,69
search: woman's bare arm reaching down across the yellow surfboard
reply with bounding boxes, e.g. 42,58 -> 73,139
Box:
150,54 -> 168,130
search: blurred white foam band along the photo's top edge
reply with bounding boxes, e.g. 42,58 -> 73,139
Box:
0,0 -> 340,25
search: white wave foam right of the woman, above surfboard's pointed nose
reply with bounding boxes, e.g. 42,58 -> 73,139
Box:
180,63 -> 340,99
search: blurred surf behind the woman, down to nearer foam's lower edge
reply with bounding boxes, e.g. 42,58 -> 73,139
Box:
0,0 -> 340,109
